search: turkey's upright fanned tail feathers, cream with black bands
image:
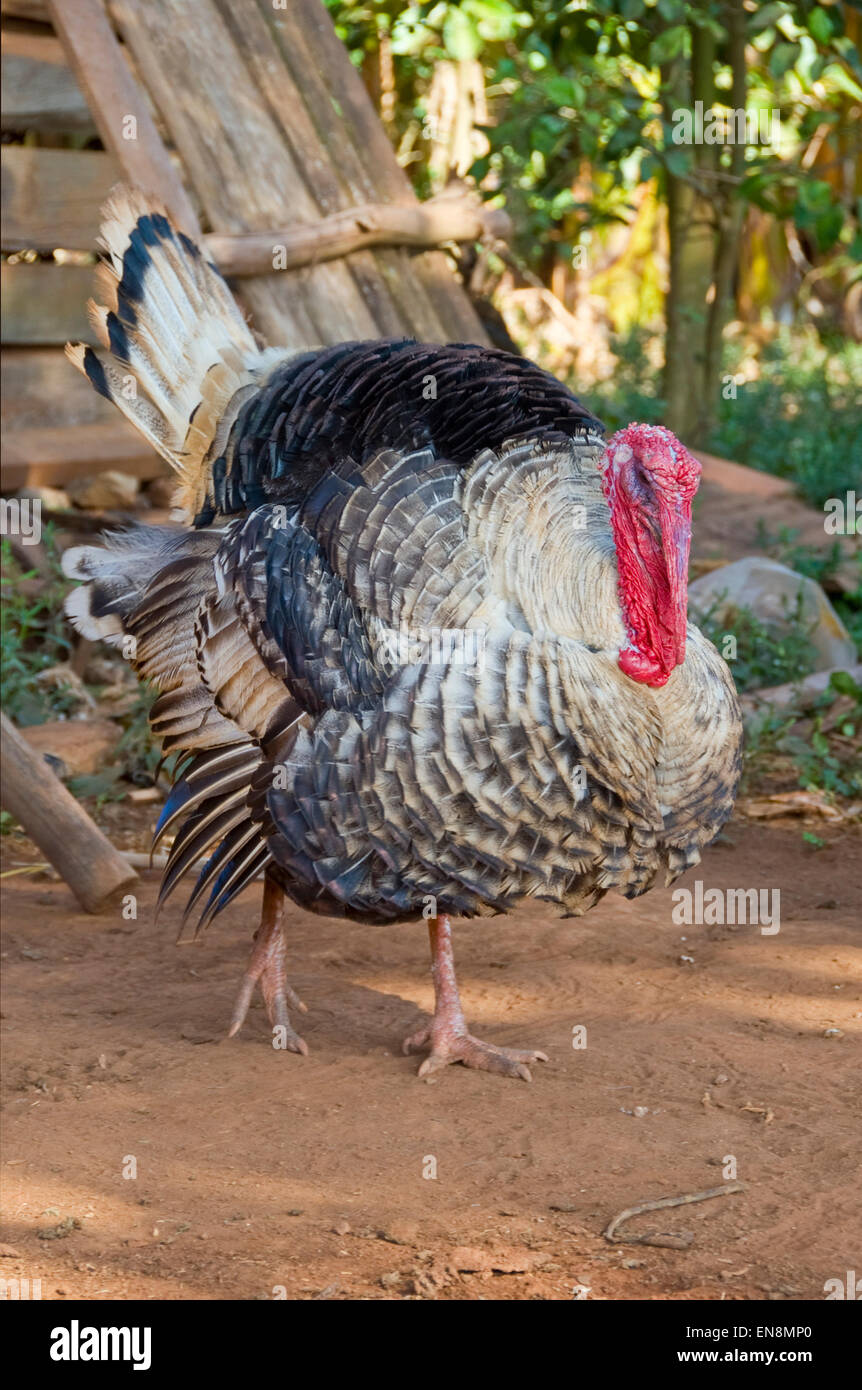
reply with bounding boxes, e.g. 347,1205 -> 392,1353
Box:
65,186 -> 284,518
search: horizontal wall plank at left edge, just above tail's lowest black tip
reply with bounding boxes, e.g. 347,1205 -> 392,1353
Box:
0,261 -> 96,345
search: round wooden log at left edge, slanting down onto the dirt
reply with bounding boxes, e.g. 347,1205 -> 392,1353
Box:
0,713 -> 139,912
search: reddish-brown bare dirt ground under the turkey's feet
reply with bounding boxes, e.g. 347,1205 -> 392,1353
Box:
0,819 -> 862,1300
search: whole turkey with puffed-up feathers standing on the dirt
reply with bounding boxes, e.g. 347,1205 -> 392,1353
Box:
64,189 -> 741,1080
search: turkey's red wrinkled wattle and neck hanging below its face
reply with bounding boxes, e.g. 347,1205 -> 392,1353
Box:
610,496 -> 691,687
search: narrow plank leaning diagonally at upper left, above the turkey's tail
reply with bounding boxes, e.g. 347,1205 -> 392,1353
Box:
50,0 -> 200,238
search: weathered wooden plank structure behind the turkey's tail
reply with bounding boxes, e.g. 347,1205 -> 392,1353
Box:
0,0 -> 499,491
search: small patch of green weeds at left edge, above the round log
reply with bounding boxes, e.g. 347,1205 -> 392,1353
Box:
0,527 -> 76,724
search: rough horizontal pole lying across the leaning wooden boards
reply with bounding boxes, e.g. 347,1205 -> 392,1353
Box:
204,197 -> 509,275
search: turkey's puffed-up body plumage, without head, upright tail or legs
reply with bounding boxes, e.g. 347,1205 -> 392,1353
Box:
79,343 -> 740,920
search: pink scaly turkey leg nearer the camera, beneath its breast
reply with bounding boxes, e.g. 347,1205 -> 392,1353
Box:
403,916 -> 548,1081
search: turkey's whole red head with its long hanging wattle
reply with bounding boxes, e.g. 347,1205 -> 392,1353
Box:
602,425 -> 701,685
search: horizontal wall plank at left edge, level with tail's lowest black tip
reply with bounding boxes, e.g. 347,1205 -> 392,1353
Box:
0,348 -> 121,430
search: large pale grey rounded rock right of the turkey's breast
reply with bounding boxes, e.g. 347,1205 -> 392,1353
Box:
688,555 -> 856,670
